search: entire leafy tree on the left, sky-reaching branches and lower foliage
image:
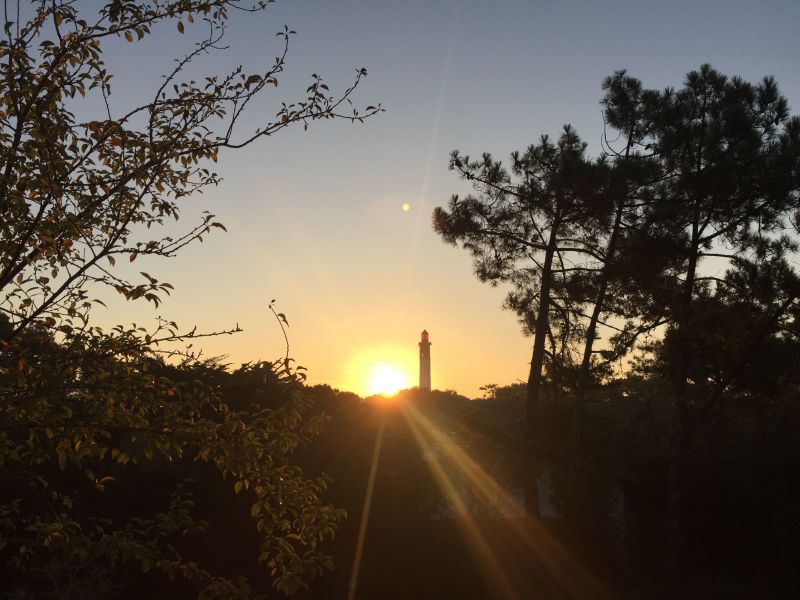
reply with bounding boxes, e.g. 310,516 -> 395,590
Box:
0,0 -> 381,597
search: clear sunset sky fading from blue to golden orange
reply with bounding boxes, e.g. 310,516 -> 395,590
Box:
92,0 -> 800,397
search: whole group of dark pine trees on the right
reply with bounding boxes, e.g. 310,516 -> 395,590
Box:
433,65 -> 800,572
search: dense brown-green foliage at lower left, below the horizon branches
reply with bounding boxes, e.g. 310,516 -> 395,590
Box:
0,318 -> 343,592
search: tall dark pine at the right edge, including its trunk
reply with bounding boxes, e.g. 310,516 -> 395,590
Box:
612,65 -> 800,565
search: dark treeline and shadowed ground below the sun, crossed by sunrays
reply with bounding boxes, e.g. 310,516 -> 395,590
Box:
3,336 -> 800,599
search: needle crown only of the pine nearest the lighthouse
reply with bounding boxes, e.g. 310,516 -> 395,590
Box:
433,127 -> 605,360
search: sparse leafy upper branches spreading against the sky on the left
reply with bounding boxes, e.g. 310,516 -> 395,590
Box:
0,0 -> 380,335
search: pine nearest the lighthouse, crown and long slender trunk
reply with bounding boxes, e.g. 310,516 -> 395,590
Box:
433,127 -> 609,513
